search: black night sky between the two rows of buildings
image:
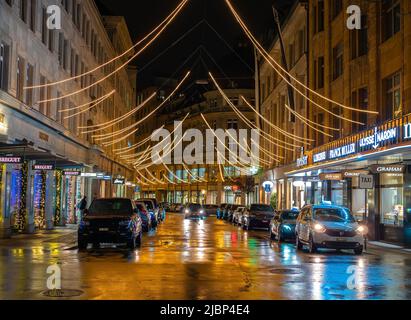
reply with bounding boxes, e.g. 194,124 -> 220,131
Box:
97,0 -> 294,88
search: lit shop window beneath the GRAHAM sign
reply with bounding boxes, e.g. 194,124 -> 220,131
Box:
380,173 -> 404,227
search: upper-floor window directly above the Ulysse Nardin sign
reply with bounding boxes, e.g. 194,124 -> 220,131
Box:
383,72 -> 402,120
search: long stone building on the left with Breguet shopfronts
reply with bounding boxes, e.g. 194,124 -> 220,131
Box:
0,0 -> 136,236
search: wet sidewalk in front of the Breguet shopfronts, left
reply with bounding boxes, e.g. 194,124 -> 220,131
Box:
0,225 -> 77,247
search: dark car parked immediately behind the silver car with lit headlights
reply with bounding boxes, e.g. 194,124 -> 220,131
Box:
270,209 -> 300,241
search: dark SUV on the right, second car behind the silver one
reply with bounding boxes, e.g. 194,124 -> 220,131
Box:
243,204 -> 274,230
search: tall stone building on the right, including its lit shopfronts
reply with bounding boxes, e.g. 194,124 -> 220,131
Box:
260,0 -> 411,245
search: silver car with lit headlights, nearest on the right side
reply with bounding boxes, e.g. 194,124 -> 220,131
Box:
295,204 -> 367,255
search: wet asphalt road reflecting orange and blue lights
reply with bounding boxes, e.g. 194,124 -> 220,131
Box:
0,214 -> 411,300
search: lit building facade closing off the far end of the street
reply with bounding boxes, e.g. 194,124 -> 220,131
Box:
137,89 -> 256,205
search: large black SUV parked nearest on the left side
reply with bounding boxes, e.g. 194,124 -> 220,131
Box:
78,198 -> 143,250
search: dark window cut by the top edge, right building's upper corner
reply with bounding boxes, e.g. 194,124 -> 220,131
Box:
381,0 -> 401,41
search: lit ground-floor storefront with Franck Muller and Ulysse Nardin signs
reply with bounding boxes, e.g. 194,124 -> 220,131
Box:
286,116 -> 411,246
